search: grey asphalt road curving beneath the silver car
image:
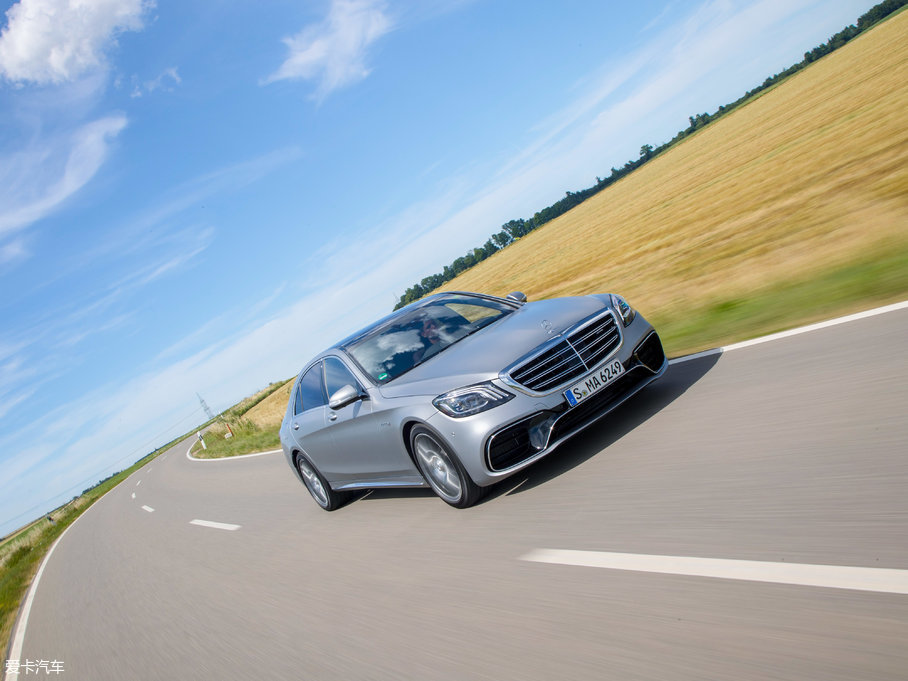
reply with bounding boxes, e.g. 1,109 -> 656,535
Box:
8,310 -> 908,681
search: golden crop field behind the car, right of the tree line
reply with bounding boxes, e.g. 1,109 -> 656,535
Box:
443,12 -> 908,350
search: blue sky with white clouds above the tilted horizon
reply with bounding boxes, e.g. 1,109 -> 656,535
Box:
0,0 -> 872,535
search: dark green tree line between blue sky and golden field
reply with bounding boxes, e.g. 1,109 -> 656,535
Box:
394,0 -> 908,310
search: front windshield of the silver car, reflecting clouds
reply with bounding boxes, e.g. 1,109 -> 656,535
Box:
345,295 -> 515,383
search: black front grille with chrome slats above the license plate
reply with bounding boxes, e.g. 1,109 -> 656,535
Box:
507,312 -> 621,393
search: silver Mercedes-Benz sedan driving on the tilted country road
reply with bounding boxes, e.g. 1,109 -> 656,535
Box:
280,292 -> 668,511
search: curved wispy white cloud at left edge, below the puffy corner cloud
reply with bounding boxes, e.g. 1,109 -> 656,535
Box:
0,115 -> 126,242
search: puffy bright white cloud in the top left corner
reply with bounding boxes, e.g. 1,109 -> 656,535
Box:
0,0 -> 153,85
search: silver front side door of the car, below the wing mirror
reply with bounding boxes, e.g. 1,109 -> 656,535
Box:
325,356 -> 419,483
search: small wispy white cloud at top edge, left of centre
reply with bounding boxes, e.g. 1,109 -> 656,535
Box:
265,0 -> 393,100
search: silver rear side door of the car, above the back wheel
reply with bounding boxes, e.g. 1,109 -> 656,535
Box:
290,360 -> 334,470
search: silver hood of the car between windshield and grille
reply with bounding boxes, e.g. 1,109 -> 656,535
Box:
381,296 -> 606,397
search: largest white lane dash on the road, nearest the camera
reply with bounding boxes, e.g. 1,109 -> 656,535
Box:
521,549 -> 908,594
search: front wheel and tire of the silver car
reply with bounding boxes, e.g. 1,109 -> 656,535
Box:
410,426 -> 485,508
